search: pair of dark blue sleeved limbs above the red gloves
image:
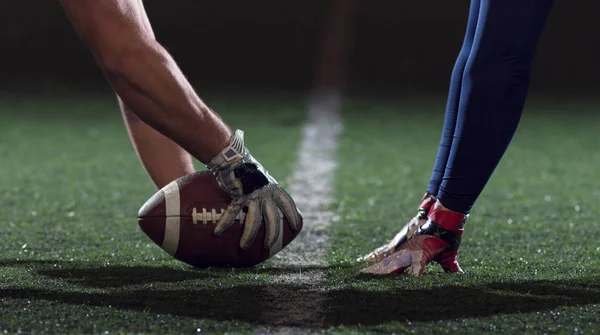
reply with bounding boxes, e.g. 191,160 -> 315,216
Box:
427,0 -> 554,214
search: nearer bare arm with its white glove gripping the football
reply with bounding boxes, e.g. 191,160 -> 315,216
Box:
61,0 -> 302,248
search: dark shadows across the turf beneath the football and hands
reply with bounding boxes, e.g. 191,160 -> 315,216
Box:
0,266 -> 600,327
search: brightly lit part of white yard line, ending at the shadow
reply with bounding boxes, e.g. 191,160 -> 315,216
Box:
281,94 -> 342,266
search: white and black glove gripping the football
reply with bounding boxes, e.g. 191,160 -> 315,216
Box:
207,130 -> 302,249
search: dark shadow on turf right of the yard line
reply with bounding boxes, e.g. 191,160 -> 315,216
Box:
328,277 -> 600,324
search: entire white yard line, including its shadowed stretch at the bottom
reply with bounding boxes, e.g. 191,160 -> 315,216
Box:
261,93 -> 342,334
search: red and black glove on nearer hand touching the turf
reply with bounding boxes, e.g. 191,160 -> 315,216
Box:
361,201 -> 468,277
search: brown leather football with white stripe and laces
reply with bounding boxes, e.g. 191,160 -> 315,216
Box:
138,171 -> 302,267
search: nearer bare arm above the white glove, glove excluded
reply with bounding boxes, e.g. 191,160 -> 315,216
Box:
60,0 -> 231,164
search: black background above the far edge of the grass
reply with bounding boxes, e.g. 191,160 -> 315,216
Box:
0,0 -> 600,95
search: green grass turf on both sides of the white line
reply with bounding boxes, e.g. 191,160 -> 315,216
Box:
0,94 -> 600,334
